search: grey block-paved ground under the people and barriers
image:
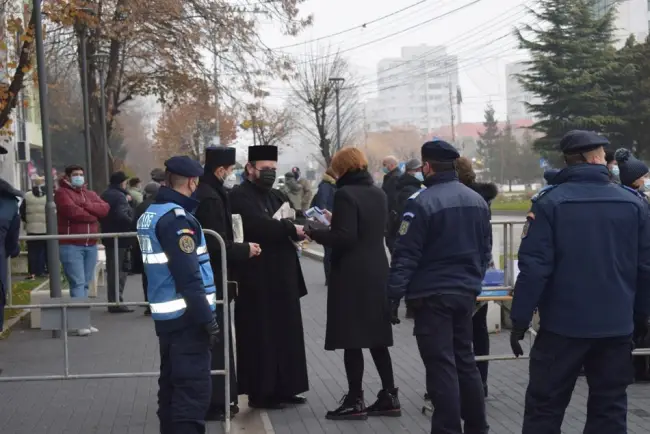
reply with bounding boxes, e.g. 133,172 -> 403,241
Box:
0,259 -> 650,434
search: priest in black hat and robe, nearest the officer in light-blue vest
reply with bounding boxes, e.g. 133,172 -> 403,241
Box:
194,146 -> 261,420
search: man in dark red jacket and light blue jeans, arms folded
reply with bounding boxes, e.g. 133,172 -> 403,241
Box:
54,165 -> 110,336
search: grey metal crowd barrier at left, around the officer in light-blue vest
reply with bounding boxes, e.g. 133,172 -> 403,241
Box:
0,229 -> 230,433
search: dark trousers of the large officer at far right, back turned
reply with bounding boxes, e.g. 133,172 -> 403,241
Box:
522,329 -> 634,434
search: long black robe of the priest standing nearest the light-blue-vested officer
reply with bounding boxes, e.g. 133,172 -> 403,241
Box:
194,173 -> 249,410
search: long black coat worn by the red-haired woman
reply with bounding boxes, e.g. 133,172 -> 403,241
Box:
311,172 -> 393,350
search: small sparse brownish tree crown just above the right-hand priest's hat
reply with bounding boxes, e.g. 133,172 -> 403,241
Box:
244,101 -> 296,147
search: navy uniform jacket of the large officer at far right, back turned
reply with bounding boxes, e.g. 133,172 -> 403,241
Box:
510,164 -> 650,338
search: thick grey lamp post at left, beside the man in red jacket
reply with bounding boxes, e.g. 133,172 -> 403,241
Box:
32,0 -> 66,337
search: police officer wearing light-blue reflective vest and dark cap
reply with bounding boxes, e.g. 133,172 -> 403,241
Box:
137,156 -> 219,434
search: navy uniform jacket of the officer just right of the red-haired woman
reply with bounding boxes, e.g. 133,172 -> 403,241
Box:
388,172 -> 492,300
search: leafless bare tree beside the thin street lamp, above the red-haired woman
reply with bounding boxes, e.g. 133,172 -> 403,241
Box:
291,50 -> 362,166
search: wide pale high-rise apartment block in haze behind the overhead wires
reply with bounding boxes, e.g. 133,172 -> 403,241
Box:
365,45 -> 458,134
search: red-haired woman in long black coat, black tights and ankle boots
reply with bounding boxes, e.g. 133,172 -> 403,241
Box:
306,148 -> 401,420
